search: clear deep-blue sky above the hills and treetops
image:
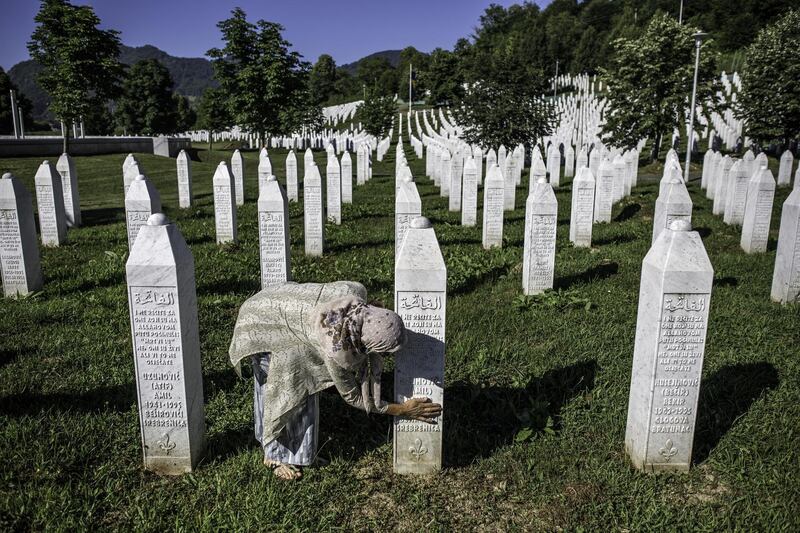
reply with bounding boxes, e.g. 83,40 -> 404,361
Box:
0,0 -> 550,70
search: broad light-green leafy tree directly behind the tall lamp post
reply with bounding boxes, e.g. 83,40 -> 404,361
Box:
601,14 -> 721,161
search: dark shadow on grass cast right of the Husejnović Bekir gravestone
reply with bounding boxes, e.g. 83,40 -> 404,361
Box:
692,362 -> 778,463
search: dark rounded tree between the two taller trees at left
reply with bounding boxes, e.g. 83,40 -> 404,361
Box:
117,59 -> 178,135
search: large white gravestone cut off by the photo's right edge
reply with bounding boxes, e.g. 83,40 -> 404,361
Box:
771,189 -> 800,304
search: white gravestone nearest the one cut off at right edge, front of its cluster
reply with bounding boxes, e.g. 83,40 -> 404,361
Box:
740,167 -> 775,254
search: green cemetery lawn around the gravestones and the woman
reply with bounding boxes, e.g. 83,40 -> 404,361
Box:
0,139 -> 800,531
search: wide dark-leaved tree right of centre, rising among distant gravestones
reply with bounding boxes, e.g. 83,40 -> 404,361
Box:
455,80 -> 555,148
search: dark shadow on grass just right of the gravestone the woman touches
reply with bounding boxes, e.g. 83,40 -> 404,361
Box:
444,360 -> 597,466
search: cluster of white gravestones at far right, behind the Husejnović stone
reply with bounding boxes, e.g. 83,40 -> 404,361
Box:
700,150 -> 800,304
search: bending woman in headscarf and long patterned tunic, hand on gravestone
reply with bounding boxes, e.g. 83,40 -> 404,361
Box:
229,281 -> 441,479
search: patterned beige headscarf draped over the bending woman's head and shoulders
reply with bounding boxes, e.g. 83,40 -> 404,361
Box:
315,296 -> 405,412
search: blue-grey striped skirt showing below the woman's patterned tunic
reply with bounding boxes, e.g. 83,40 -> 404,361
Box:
251,353 -> 319,466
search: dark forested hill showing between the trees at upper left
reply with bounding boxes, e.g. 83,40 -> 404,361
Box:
8,45 -> 216,120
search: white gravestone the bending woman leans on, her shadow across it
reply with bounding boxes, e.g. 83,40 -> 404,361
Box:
393,217 -> 447,474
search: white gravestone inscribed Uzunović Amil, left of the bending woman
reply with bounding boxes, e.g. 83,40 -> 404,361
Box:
125,213 -> 205,475
